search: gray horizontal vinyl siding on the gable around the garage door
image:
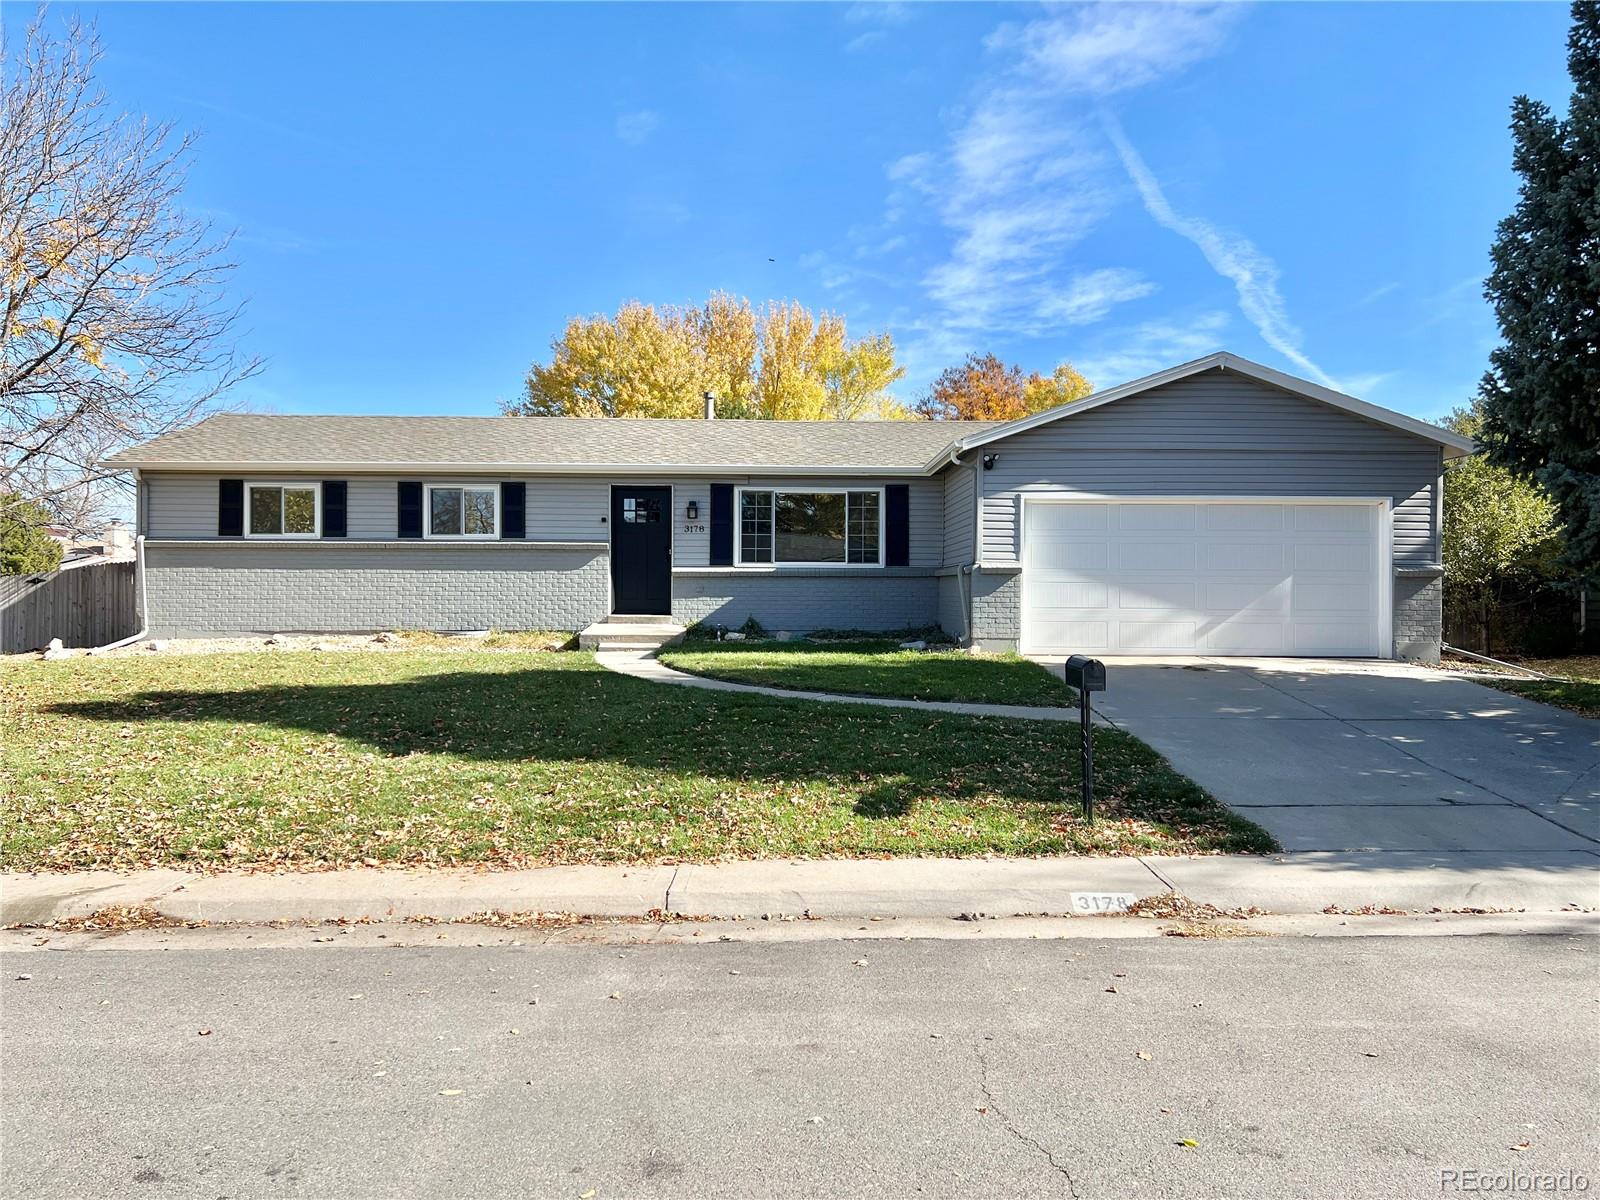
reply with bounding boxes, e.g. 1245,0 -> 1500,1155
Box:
982,371 -> 1442,566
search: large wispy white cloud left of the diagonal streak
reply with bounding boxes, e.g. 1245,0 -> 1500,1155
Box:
850,5 -> 1237,352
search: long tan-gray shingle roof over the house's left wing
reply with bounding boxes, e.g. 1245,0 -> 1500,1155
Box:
107,413 -> 1000,470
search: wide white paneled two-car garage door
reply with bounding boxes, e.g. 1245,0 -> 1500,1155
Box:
1022,498 -> 1384,658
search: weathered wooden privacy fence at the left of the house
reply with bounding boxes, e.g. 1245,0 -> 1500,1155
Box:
0,563 -> 139,654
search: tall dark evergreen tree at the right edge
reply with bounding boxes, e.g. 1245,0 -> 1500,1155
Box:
1482,0 -> 1600,578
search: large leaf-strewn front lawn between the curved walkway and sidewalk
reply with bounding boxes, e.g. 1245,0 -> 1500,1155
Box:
0,651 -> 1272,870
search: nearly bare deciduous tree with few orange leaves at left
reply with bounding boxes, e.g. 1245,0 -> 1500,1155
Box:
0,11 -> 259,533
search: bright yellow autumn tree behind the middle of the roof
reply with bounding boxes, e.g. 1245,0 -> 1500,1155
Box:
506,293 -> 907,421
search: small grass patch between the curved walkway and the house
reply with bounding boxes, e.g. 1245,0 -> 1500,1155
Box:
659,642 -> 1075,706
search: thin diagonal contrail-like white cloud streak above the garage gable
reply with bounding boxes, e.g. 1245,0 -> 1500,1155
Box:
1104,114 -> 1338,387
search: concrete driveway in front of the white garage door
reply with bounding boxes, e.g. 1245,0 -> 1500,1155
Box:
1036,658 -> 1600,856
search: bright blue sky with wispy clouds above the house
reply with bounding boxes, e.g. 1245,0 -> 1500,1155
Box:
46,3 -> 1568,418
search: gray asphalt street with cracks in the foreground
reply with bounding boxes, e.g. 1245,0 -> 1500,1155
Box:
0,926 -> 1600,1200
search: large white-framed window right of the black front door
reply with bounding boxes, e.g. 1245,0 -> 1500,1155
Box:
736,488 -> 883,566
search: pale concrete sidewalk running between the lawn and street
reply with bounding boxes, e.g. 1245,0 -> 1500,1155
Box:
0,851 -> 1600,925
